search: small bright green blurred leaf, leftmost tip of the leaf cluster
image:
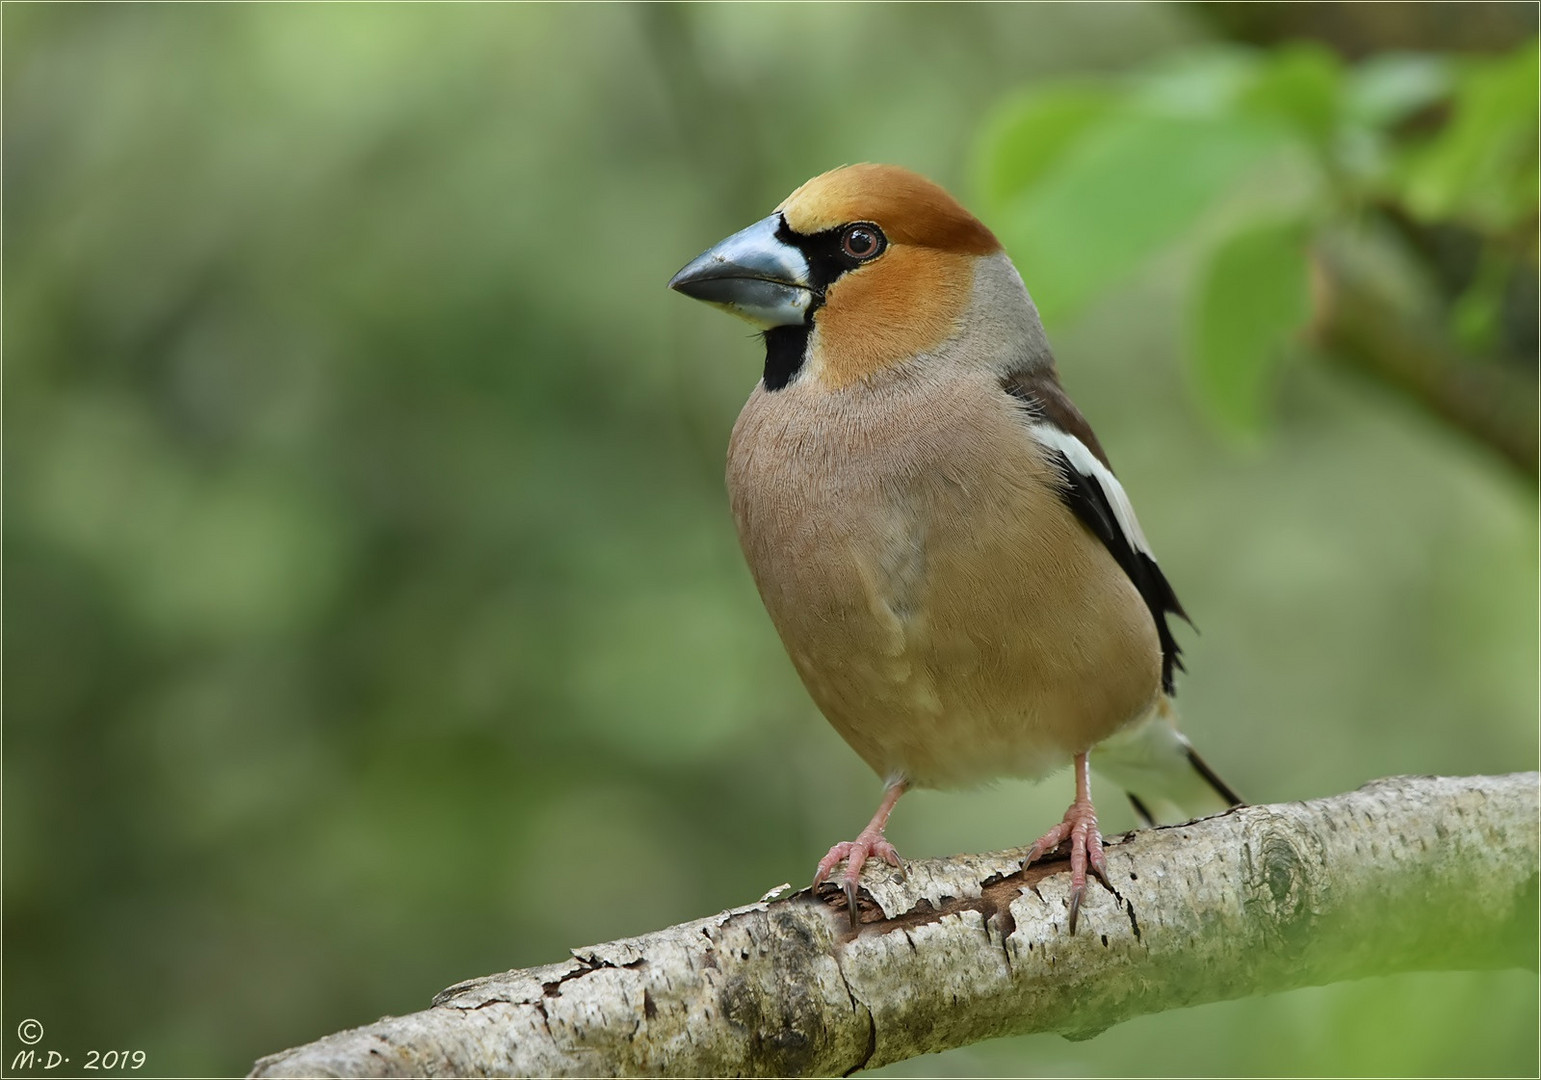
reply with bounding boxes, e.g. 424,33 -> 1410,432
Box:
977,83 -> 1116,205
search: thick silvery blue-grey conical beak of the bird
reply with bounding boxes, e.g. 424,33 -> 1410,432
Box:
669,213 -> 814,330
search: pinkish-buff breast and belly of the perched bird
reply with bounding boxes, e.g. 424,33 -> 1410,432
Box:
727,366 -> 1160,787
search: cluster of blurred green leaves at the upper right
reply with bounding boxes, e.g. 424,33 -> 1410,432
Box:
977,39 -> 1538,443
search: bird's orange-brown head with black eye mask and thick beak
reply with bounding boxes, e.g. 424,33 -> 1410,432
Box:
669,165 -> 1037,390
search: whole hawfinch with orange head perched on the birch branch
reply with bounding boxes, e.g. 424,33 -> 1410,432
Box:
669,163 -> 1241,934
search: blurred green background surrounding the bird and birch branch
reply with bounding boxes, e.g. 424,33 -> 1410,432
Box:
5,5 -> 1538,1075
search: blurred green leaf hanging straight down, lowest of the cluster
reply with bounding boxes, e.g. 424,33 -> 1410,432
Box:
1190,220 -> 1310,434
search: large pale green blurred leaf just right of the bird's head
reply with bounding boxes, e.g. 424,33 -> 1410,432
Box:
995,111 -> 1288,325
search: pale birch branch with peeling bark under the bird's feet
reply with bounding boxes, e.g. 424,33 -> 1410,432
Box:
253,772 -> 1538,1077
